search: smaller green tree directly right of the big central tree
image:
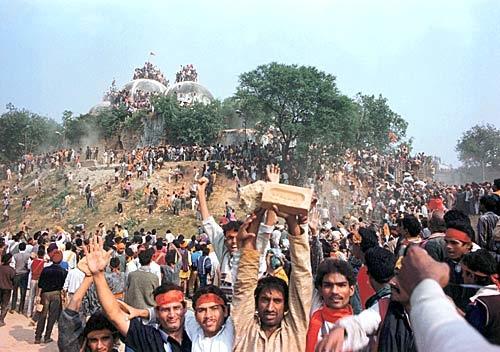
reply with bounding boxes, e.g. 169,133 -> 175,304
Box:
355,93 -> 408,151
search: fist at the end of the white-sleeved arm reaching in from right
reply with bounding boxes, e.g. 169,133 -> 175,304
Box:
398,246 -> 450,296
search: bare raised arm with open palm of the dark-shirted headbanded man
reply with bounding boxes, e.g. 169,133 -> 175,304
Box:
85,236 -> 130,336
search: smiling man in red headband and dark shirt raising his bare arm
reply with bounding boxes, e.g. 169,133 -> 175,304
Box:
87,236 -> 191,352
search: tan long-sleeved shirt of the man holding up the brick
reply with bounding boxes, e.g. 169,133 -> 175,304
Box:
231,232 -> 313,352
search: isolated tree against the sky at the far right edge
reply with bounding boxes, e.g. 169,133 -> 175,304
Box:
455,124 -> 500,179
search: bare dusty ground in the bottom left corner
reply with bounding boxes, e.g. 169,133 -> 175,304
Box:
0,313 -> 58,352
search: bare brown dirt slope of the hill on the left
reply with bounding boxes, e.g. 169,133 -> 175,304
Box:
0,162 -> 241,236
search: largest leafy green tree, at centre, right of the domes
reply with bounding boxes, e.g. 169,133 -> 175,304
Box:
236,62 -> 357,178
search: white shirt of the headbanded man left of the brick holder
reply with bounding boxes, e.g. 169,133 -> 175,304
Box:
184,310 -> 234,352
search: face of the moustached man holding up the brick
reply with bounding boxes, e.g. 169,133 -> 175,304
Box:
257,289 -> 285,329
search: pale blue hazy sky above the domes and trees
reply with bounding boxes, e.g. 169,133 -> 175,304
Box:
0,0 -> 500,166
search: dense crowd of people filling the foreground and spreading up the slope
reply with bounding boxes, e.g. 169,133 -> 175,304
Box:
0,152 -> 500,352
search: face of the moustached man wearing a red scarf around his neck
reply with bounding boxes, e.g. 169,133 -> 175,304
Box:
320,273 -> 354,309
